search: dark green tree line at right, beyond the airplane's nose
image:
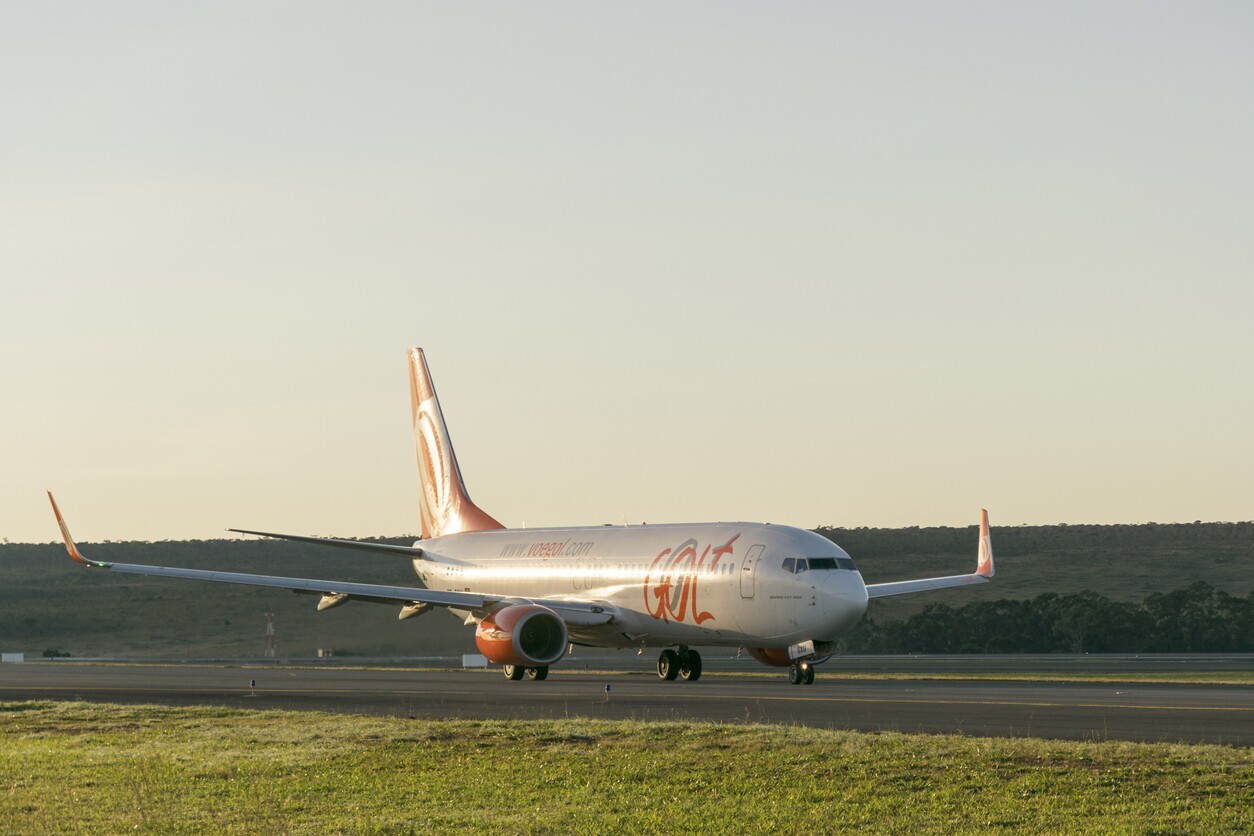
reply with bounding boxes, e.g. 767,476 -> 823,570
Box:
839,582 -> 1254,653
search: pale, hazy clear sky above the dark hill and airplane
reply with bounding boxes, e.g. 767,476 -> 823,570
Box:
0,0 -> 1254,543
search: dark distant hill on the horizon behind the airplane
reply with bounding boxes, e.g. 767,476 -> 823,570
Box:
0,523 -> 1254,658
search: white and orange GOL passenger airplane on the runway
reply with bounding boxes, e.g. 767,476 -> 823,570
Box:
48,348 -> 993,684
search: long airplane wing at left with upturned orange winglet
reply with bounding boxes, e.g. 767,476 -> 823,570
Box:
48,491 -> 613,627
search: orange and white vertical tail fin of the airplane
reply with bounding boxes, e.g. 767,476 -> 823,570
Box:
409,348 -> 505,539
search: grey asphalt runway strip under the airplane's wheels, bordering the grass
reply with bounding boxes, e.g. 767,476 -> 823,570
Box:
0,662 -> 1254,746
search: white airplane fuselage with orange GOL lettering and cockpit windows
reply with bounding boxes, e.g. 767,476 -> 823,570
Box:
414,523 -> 867,648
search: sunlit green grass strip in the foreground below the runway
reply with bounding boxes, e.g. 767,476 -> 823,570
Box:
0,702 -> 1254,833
